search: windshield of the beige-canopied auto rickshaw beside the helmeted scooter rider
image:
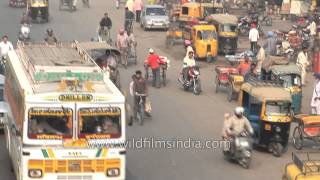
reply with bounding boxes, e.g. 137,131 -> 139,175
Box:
266,101 -> 290,116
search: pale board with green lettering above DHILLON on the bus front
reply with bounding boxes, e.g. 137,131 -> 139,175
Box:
34,72 -> 104,81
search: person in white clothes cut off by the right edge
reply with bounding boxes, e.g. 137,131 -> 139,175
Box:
311,74 -> 320,115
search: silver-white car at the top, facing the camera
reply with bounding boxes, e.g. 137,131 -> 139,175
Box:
140,5 -> 170,30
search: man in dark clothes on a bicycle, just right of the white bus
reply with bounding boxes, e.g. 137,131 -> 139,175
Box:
133,70 -> 148,119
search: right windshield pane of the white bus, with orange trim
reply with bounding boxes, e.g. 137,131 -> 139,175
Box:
79,107 -> 121,139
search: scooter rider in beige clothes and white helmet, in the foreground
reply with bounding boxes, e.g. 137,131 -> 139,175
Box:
224,107 -> 254,154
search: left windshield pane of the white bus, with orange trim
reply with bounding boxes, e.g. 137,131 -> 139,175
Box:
28,107 -> 72,139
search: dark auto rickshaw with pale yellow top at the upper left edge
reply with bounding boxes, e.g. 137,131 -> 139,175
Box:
27,0 -> 49,23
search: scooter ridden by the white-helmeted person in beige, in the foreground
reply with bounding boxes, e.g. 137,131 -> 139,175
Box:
223,132 -> 252,169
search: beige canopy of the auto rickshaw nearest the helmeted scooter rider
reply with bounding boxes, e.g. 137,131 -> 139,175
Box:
241,82 -> 292,102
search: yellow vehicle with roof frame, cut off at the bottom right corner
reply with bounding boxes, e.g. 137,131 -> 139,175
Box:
282,152 -> 320,180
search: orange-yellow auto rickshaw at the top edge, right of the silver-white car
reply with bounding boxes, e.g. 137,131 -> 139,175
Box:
179,2 -> 225,21
